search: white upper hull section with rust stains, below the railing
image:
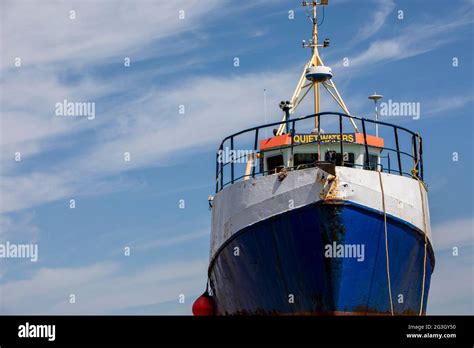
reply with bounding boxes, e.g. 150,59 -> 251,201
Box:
210,167 -> 431,259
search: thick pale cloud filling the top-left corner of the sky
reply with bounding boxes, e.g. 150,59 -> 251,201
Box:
1,0 -> 220,67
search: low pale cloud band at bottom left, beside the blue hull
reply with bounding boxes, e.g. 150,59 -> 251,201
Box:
0,256 -> 207,314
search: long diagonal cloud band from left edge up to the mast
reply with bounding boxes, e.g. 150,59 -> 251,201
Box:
1,71 -> 293,212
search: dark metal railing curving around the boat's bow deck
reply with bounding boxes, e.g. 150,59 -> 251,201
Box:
216,112 -> 423,192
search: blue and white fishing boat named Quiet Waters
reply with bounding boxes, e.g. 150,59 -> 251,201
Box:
193,0 -> 435,315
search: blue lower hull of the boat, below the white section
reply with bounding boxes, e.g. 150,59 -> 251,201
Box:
209,202 -> 434,315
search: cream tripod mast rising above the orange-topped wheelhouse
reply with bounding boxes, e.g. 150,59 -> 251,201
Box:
276,0 -> 359,135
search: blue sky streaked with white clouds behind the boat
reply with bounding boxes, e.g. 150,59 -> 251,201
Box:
0,0 -> 474,314
